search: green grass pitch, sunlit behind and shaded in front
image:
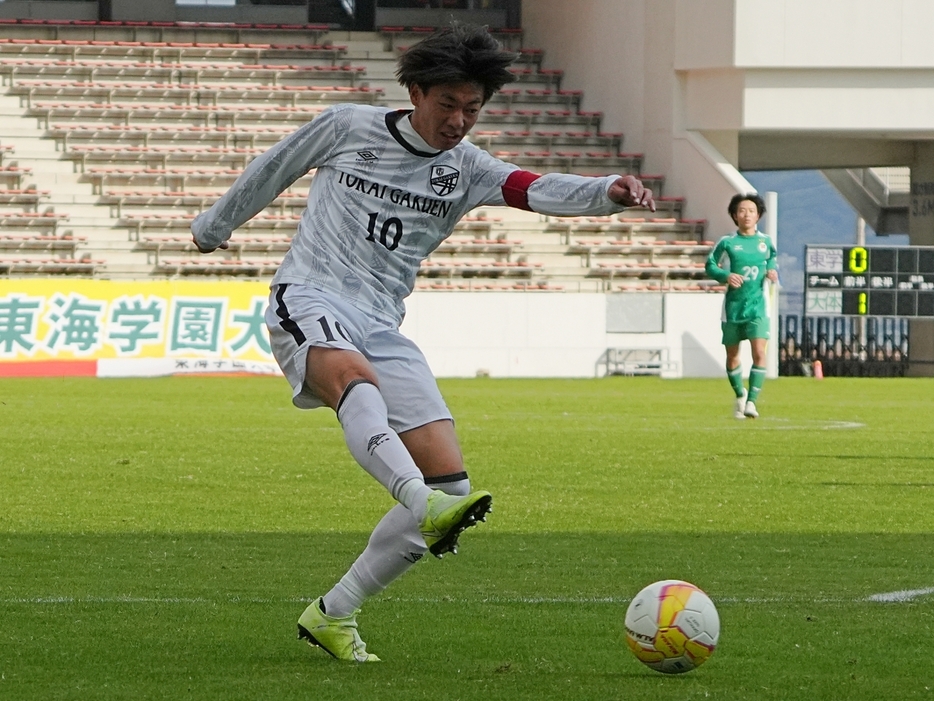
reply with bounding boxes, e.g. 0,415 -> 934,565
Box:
0,378 -> 934,701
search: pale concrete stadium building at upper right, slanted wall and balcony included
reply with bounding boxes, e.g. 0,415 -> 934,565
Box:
523,0 -> 934,224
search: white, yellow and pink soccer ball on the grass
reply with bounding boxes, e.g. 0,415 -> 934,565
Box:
626,579 -> 720,674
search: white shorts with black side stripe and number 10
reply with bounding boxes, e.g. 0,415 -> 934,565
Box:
266,284 -> 452,433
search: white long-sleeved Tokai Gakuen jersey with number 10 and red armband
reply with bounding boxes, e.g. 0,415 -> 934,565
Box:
191,104 -> 623,326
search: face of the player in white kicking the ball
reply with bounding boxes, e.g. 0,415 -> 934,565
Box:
409,83 -> 483,151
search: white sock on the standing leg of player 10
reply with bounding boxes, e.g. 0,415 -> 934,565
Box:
324,472 -> 470,618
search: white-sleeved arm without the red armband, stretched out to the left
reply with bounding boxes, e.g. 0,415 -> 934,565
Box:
191,111 -> 346,253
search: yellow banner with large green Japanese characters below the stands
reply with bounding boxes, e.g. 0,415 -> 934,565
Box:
0,278 -> 274,378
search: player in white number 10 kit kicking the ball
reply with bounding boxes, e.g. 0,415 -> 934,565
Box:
191,24 -> 655,662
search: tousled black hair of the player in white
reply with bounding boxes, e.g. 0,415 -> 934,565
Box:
396,22 -> 516,104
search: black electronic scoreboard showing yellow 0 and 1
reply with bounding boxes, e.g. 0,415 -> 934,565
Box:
804,244 -> 934,317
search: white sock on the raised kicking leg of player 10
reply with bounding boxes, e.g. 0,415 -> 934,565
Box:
337,381 -> 431,520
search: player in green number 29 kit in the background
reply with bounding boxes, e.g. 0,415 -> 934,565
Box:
706,194 -> 778,419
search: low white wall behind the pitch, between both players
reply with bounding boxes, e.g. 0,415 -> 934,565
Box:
402,292 -> 732,377
